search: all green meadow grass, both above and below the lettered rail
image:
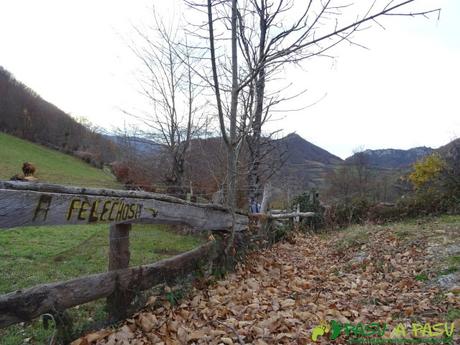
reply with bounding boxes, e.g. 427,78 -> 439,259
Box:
0,133 -> 205,345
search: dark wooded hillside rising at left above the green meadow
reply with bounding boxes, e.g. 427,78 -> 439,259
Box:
0,66 -> 117,164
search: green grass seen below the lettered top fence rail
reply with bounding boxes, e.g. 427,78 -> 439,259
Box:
0,224 -> 203,345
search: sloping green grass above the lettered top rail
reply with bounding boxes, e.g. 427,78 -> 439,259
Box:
0,133 -> 121,188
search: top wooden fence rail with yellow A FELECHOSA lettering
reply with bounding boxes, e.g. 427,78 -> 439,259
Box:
0,181 -> 248,231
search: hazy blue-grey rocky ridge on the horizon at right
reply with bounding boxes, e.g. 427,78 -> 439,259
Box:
345,146 -> 434,169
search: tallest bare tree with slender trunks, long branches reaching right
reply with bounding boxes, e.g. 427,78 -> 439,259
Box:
186,0 -> 439,208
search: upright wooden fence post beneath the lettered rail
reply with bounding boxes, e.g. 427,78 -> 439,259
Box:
107,224 -> 133,320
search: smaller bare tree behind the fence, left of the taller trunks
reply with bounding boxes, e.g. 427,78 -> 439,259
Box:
125,15 -> 206,195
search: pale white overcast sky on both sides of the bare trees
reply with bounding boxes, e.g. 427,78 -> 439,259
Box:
0,0 -> 460,158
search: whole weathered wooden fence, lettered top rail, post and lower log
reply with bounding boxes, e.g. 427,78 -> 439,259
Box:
0,181 -> 248,327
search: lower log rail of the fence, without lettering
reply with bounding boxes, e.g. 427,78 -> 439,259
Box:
0,241 -> 220,327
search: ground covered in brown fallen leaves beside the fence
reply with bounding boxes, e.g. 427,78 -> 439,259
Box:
73,217 -> 460,345
